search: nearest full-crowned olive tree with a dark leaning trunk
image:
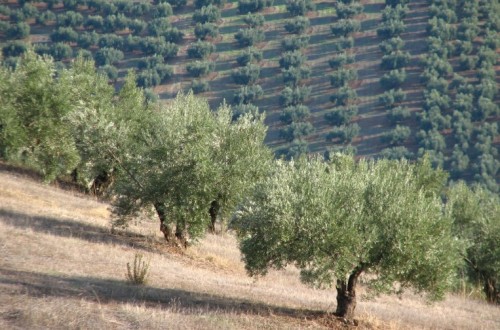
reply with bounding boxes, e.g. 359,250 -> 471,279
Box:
232,154 -> 458,320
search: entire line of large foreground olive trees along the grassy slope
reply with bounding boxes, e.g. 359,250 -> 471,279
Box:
0,52 -> 500,320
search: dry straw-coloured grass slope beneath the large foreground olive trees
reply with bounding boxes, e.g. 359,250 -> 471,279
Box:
0,172 -> 500,329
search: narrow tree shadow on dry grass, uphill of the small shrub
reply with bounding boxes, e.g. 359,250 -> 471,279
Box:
0,208 -> 157,252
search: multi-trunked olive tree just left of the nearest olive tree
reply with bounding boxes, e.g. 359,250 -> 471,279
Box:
72,90 -> 268,246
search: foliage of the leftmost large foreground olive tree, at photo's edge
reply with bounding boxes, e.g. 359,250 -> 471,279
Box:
0,51 -> 79,181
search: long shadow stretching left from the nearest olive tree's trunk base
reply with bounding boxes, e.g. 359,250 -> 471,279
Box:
0,268 -> 330,320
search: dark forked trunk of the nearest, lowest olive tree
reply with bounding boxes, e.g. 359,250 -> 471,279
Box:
335,266 -> 363,321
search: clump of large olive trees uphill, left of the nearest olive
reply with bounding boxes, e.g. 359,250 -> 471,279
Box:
0,52 -> 272,244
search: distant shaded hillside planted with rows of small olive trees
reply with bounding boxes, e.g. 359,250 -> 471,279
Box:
0,0 -> 500,191
